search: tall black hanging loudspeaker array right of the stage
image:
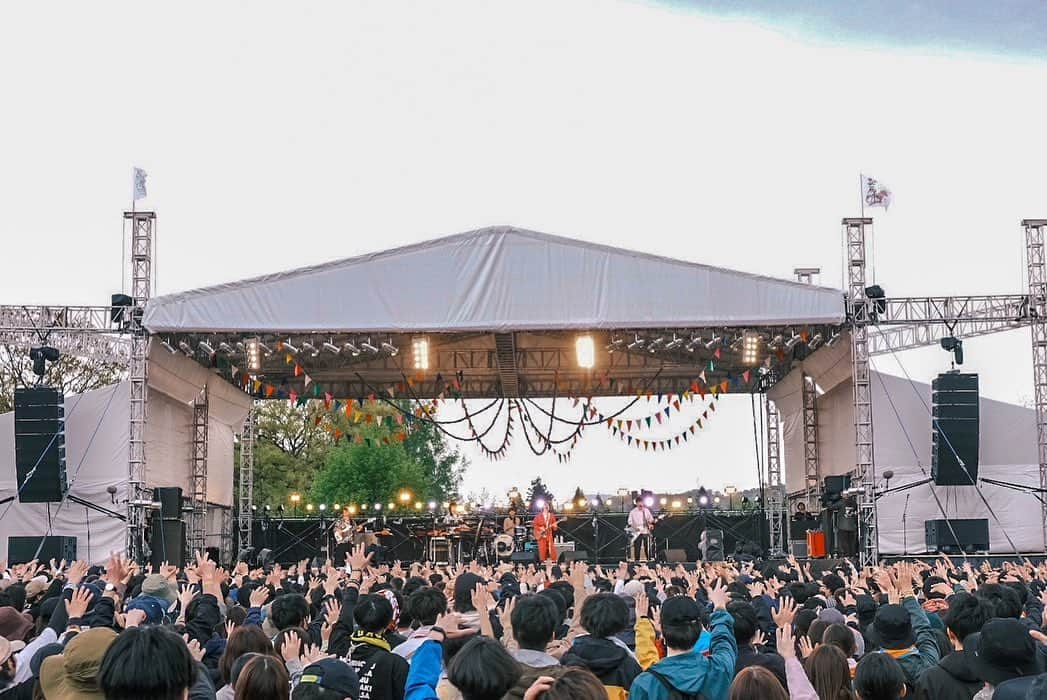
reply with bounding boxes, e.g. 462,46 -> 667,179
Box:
931,372 -> 979,487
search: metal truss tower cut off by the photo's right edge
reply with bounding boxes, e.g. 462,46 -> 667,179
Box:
1022,219 -> 1047,548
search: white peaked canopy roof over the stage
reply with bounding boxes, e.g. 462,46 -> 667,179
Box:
144,226 -> 844,333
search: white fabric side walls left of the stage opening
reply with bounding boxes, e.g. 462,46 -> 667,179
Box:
0,351 -> 251,563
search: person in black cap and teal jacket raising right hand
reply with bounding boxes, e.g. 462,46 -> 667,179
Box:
629,583 -> 738,700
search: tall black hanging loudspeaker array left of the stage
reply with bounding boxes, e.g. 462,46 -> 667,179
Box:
15,387 -> 68,503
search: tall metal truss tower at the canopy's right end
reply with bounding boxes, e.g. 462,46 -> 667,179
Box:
843,218 -> 879,566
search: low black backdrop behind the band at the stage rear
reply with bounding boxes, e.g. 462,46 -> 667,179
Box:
252,511 -> 767,564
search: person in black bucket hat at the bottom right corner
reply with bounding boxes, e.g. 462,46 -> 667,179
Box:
965,617 -> 1043,700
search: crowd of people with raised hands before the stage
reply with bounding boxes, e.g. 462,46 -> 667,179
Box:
0,547 -> 1047,700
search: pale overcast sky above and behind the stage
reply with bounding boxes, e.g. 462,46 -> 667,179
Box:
0,0 -> 1047,502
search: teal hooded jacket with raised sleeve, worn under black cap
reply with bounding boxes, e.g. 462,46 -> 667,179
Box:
628,610 -> 738,700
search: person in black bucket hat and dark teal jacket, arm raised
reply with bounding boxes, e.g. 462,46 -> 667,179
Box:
866,563 -> 940,691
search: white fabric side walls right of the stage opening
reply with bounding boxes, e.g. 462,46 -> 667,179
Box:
770,339 -> 1045,555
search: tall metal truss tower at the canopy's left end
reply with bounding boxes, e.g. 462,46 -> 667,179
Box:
124,211 -> 156,562
